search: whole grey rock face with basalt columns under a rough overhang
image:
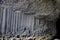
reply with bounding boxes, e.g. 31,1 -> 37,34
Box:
0,0 -> 60,37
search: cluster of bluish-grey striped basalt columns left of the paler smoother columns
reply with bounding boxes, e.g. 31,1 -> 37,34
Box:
0,8 -> 22,35
